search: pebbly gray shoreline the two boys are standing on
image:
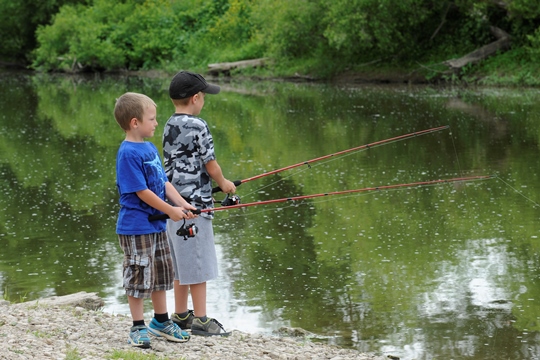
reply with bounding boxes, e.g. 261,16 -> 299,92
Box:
0,292 -> 387,360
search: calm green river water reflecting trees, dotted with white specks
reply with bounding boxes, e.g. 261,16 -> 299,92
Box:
0,73 -> 540,360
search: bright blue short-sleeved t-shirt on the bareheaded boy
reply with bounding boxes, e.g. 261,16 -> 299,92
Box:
116,141 -> 167,235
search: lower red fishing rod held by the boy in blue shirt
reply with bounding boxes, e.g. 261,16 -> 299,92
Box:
153,175 -> 495,221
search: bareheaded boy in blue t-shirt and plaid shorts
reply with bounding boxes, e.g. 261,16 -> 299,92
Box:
114,93 -> 196,348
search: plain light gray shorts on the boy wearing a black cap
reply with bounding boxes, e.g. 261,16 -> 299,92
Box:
167,216 -> 218,285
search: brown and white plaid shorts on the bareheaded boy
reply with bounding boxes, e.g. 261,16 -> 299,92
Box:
118,232 -> 174,299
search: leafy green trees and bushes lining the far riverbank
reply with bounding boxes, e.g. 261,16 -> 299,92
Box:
0,0 -> 540,76
